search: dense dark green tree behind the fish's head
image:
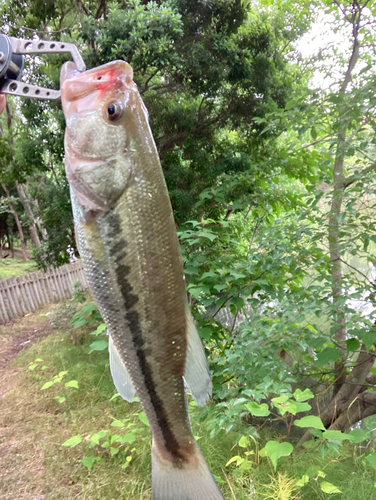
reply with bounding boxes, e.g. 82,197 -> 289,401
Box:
0,0 -> 311,263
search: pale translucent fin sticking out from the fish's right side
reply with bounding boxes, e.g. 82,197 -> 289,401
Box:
184,307 -> 213,406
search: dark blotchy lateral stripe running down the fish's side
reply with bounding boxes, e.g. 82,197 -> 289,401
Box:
107,213 -> 184,459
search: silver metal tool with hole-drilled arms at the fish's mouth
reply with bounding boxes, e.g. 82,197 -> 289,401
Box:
0,34 -> 86,101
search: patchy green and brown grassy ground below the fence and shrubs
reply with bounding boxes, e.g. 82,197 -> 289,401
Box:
0,302 -> 376,500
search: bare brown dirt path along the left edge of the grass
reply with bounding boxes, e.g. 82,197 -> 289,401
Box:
0,305 -> 56,500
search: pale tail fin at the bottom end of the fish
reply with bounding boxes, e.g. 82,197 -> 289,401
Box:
151,446 -> 224,500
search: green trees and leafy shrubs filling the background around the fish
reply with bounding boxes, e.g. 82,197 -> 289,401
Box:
0,0 -> 376,499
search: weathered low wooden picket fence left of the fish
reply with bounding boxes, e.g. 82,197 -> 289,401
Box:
0,262 -> 87,324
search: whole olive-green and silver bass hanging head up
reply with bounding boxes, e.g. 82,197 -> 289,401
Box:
61,61 -> 223,500
